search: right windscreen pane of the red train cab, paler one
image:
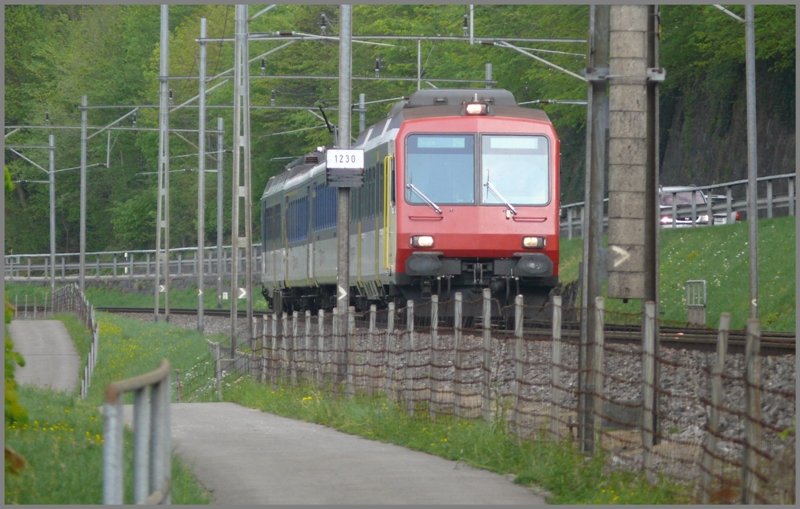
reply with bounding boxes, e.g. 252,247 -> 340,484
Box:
481,135 -> 550,205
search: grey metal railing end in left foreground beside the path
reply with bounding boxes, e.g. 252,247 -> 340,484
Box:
103,359 -> 172,505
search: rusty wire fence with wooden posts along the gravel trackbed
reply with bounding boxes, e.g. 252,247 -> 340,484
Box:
207,290 -> 795,503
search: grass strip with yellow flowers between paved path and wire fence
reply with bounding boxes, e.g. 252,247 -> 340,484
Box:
223,377 -> 689,504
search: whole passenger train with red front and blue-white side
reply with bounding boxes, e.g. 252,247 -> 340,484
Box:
260,89 -> 560,317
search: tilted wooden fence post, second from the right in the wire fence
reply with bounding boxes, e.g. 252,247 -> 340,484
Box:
701,313 -> 731,505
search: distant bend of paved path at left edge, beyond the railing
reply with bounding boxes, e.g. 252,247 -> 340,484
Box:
8,320 -> 80,392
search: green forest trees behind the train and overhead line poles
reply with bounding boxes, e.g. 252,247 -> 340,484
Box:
4,3 -> 797,253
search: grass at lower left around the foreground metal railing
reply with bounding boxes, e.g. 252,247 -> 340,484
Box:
4,313 -> 213,505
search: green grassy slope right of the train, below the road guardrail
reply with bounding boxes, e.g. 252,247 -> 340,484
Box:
559,217 -> 797,332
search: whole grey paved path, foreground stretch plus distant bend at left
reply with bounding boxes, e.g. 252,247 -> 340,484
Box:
9,320 -> 545,506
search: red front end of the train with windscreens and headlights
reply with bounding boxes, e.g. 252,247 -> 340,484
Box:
395,90 -> 559,318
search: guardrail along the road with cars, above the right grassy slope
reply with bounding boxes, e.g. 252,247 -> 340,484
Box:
561,173 -> 797,239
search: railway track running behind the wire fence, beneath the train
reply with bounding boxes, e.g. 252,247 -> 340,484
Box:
89,307 -> 796,355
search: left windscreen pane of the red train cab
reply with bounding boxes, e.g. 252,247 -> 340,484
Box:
405,134 -> 475,204
